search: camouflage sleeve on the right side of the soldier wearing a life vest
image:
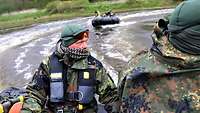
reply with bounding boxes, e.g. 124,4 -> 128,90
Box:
97,68 -> 120,113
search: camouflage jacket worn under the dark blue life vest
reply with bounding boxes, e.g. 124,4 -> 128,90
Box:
22,53 -> 119,113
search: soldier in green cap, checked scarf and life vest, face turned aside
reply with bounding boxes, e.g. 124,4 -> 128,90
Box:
22,24 -> 119,113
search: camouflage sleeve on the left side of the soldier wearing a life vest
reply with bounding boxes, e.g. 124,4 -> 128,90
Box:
21,59 -> 50,113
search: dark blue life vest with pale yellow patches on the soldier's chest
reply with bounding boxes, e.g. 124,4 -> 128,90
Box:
50,54 -> 102,110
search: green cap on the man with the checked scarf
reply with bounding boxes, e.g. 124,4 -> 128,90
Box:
61,24 -> 88,47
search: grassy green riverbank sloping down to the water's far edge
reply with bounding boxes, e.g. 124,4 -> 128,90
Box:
0,0 -> 176,34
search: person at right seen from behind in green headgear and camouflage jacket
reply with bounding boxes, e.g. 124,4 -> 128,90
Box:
120,0 -> 200,113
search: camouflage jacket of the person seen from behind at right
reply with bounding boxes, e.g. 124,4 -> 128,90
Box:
120,31 -> 200,113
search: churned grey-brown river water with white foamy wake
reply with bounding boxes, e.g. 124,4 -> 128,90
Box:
0,9 -> 172,90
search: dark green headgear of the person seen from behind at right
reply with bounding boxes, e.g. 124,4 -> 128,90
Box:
168,0 -> 200,55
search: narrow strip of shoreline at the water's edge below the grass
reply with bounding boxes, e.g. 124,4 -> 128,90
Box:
0,5 -> 175,34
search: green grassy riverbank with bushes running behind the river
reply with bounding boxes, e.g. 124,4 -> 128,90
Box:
0,0 -> 177,33
